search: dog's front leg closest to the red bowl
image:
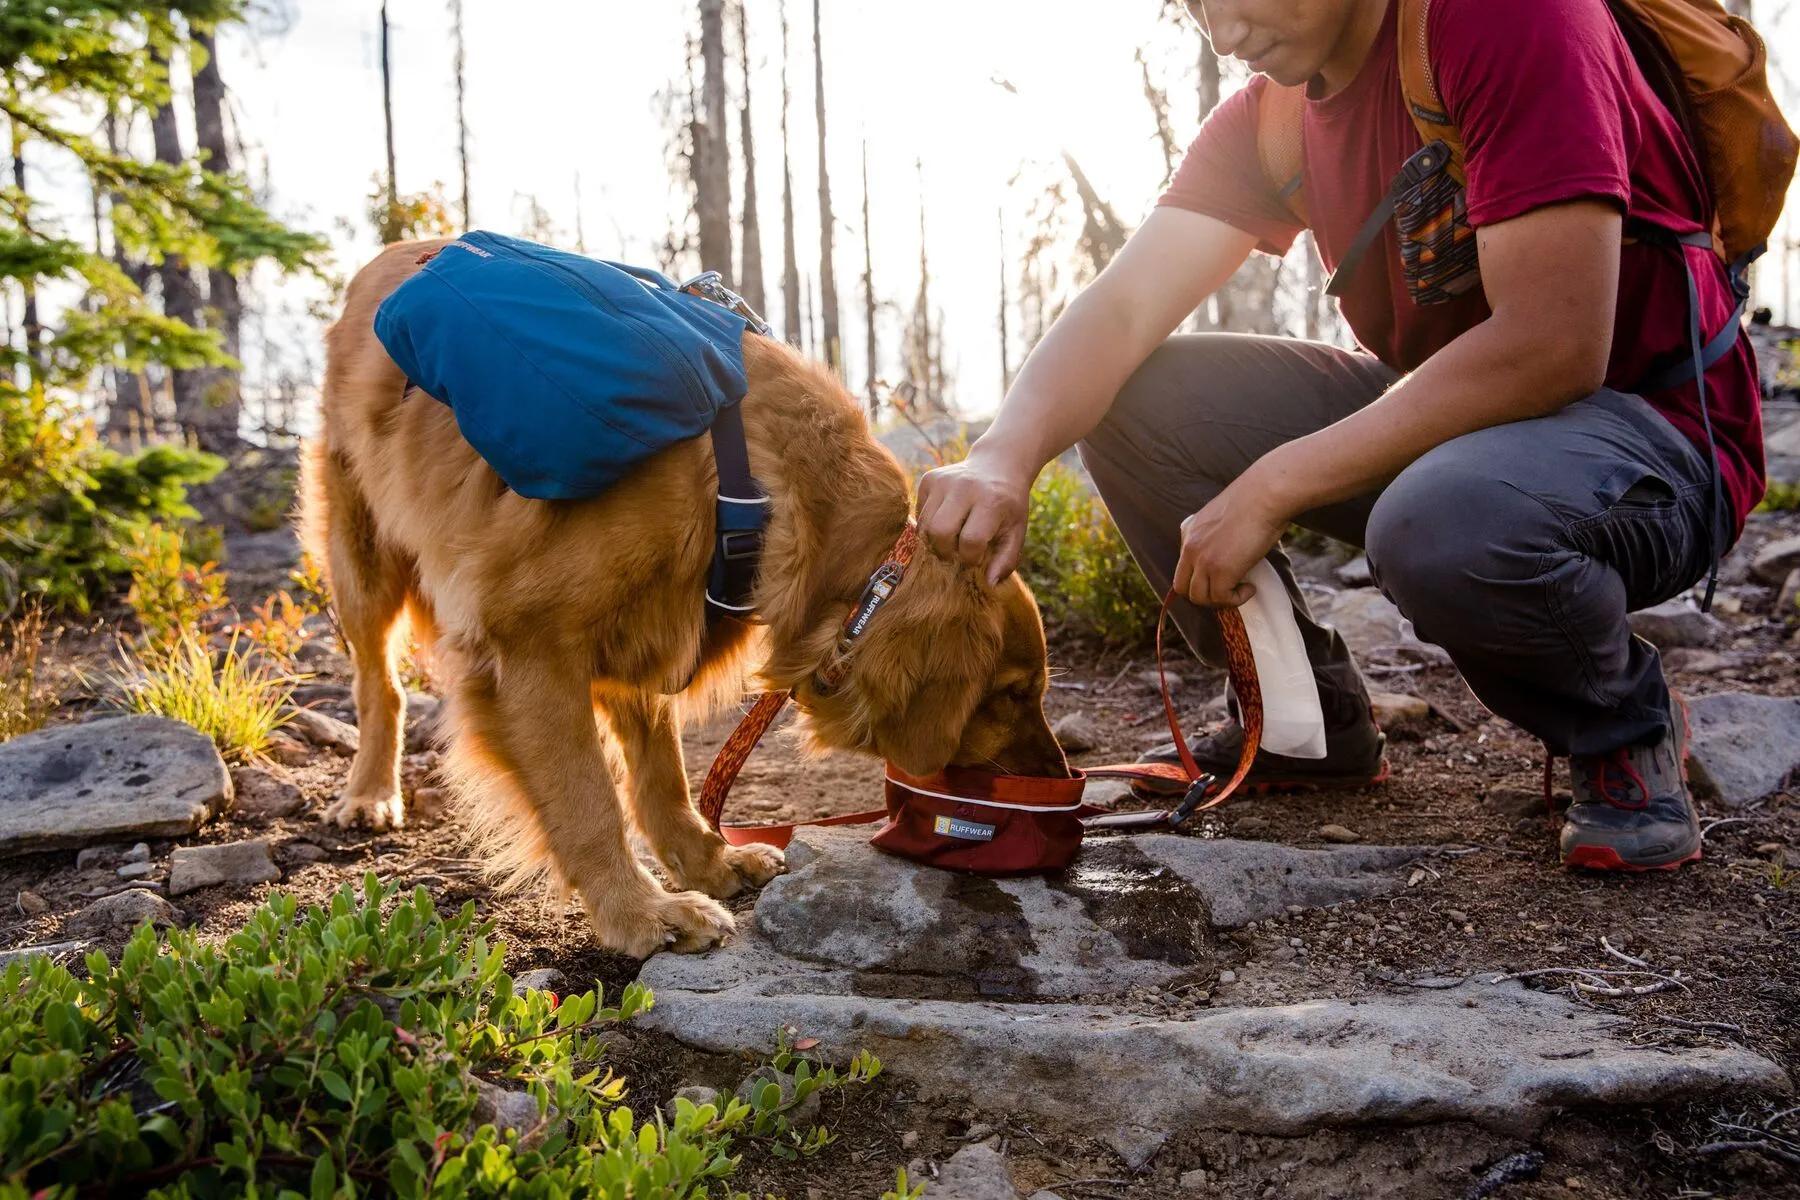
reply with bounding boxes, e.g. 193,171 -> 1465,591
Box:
599,689 -> 783,900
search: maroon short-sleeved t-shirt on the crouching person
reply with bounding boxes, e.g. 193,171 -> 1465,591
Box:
1161,0 -> 1764,518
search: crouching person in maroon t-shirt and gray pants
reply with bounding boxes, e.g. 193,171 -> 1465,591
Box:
920,0 -> 1793,871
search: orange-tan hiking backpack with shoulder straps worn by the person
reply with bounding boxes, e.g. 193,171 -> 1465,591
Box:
1256,0 -> 1800,282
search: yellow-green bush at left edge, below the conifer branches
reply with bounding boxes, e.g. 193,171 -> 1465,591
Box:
0,381 -> 225,612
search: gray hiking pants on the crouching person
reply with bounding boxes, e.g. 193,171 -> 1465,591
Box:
1080,333 -> 1733,756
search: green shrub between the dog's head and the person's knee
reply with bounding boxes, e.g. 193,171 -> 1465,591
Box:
1019,462 -> 1161,644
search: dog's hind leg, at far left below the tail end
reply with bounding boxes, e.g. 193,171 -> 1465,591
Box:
308,452 -> 412,829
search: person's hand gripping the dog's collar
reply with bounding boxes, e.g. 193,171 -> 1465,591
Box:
918,444 -> 1035,583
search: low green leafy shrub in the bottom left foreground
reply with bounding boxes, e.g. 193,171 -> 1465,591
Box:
0,874 -> 795,1200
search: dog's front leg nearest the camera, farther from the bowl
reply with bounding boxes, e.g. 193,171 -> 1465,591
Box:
459,658 -> 734,957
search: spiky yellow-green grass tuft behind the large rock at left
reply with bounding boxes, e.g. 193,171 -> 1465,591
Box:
112,630 -> 299,763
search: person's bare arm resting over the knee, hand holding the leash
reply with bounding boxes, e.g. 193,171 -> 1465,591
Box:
1174,200 -> 1622,606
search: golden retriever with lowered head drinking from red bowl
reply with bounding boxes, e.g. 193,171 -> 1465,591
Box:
301,241 -> 1067,957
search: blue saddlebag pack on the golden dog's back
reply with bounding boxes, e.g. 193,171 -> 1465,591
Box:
374,232 -> 754,500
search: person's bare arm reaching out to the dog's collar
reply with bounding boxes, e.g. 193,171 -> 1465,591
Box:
918,207 -> 1256,583
